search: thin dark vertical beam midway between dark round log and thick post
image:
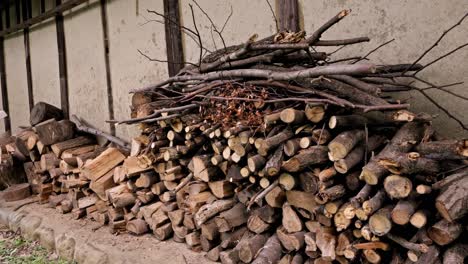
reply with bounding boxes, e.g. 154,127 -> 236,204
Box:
101,0 -> 115,136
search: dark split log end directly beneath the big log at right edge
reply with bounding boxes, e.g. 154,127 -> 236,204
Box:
427,219 -> 464,246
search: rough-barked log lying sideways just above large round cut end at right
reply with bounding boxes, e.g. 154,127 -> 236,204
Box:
379,152 -> 440,175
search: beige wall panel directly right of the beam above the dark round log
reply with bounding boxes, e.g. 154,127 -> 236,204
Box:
64,1 -> 109,131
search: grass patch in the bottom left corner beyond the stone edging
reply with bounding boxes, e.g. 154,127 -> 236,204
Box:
0,229 -> 73,264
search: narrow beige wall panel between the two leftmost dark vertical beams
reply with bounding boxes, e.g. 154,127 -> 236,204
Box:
1,32 -> 29,132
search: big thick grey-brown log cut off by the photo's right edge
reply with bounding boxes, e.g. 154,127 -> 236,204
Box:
435,176 -> 468,222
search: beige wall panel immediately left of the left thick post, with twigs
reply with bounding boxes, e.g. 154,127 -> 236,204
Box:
107,0 -> 167,138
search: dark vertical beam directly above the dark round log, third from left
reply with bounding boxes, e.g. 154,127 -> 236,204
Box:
55,0 -> 70,118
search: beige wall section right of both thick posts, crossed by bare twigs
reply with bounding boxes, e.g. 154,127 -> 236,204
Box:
300,0 -> 468,136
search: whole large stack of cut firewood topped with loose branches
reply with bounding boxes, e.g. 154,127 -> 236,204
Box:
3,11 -> 468,263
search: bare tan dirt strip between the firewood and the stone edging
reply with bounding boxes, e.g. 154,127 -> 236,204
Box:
0,201 -> 213,264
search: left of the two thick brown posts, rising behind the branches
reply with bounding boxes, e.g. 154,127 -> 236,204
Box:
164,0 -> 184,76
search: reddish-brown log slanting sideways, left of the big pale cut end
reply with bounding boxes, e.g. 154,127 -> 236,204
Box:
282,146 -> 328,172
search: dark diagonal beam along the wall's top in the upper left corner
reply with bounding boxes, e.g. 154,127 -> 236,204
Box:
0,0 -> 89,36
